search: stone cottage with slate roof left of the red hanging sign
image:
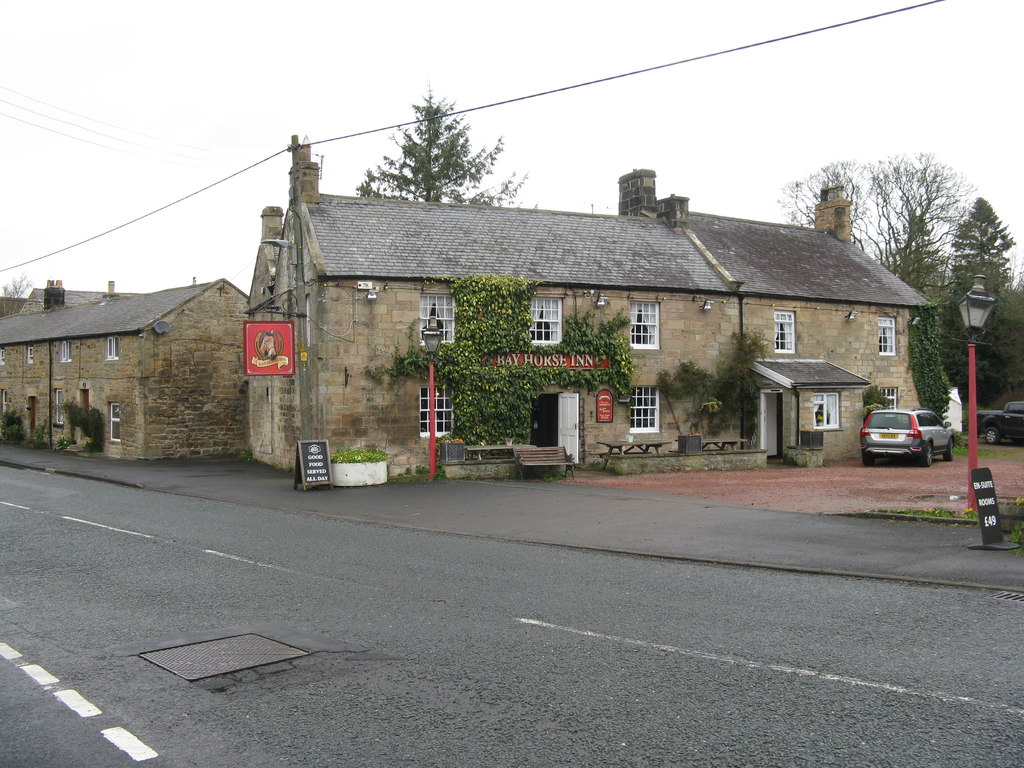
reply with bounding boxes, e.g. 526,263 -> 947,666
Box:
0,280 -> 247,459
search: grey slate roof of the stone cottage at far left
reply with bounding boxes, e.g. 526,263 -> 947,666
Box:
0,283 -> 213,344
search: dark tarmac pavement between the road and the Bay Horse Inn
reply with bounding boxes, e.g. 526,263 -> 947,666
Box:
6,444 -> 1024,592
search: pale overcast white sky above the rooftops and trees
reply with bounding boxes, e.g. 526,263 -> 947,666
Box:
0,0 -> 1024,292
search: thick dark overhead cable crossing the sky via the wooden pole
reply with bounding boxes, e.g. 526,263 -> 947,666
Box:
0,0 -> 945,272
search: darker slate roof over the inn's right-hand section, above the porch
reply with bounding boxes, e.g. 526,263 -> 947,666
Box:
690,213 -> 925,306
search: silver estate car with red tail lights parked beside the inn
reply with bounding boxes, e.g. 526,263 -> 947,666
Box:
860,409 -> 953,467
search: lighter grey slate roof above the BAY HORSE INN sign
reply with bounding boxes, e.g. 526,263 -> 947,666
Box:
309,195 -> 728,291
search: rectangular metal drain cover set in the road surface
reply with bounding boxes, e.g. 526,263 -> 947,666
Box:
138,635 -> 309,680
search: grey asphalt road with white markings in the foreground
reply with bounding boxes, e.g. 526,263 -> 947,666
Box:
0,468 -> 1024,768
